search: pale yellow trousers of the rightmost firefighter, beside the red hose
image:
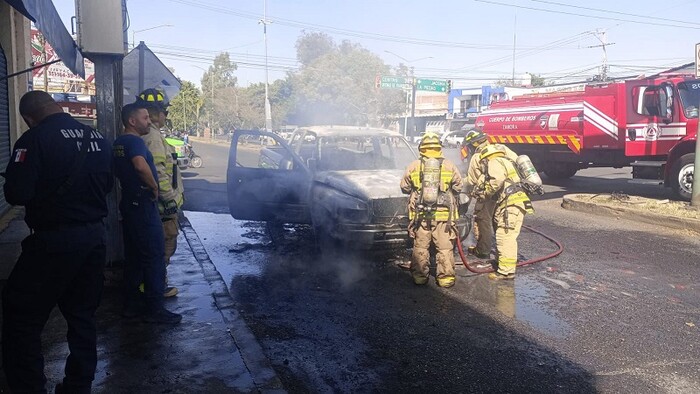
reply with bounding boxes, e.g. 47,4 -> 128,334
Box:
494,205 -> 525,275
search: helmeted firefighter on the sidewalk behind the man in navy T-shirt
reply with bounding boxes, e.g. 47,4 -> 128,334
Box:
138,89 -> 185,297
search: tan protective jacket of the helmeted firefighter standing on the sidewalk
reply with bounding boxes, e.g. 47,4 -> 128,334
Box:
141,124 -> 185,218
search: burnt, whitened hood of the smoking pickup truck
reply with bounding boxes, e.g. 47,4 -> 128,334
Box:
314,170 -> 405,200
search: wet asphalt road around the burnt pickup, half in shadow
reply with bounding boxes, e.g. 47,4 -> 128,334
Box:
185,143 -> 700,393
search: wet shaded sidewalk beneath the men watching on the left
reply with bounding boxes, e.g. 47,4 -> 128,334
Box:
0,211 -> 284,393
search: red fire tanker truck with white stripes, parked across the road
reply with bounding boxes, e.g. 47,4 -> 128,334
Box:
475,73 -> 700,200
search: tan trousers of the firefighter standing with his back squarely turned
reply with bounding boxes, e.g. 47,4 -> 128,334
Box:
411,220 -> 457,278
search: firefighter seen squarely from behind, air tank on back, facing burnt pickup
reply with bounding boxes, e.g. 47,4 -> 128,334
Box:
401,133 -> 462,287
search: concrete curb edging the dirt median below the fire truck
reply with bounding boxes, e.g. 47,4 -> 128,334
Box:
561,194 -> 700,233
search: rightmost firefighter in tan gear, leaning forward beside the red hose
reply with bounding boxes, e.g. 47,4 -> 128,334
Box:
472,145 -> 534,280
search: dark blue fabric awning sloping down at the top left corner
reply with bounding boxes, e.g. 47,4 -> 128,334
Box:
4,0 -> 85,78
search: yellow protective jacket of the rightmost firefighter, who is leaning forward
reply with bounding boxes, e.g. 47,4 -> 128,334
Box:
474,156 -> 534,213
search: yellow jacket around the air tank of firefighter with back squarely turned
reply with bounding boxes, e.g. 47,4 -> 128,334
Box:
401,159 -> 462,223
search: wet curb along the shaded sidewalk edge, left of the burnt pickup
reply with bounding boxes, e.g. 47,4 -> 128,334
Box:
179,215 -> 286,393
